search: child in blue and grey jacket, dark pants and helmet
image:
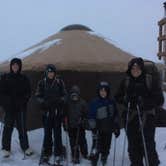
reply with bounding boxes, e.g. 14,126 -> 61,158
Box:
89,82 -> 120,165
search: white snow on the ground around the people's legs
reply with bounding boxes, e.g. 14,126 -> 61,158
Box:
0,125 -> 166,166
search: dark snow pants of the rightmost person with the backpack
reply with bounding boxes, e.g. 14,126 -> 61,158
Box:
127,115 -> 160,166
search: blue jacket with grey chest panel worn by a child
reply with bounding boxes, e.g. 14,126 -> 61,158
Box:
88,97 -> 119,132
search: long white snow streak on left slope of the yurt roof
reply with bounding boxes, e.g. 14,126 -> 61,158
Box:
6,39 -> 62,59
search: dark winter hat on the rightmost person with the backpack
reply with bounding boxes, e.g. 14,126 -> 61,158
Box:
127,58 -> 144,74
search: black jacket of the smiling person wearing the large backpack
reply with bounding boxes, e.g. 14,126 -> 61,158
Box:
115,73 -> 164,111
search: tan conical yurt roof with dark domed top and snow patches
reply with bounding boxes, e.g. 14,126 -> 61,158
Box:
0,24 -> 133,72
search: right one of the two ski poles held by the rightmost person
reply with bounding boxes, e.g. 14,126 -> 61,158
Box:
137,105 -> 149,166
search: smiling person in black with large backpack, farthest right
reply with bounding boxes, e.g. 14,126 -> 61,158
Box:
115,58 -> 163,166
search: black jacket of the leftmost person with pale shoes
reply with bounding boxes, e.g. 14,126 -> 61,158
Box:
0,72 -> 31,111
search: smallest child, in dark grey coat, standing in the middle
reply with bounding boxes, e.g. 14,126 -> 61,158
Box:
65,86 -> 88,163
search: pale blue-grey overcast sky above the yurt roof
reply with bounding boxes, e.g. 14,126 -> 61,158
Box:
0,0 -> 165,61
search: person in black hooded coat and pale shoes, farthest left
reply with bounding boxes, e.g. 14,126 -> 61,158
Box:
0,58 -> 32,157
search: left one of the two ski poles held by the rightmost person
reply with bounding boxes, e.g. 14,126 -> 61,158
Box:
122,102 -> 130,166
